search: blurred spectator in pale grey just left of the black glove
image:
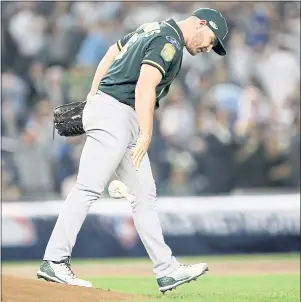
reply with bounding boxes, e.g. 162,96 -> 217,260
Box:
15,100 -> 54,199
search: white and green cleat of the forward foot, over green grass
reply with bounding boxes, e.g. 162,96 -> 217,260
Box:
157,263 -> 208,293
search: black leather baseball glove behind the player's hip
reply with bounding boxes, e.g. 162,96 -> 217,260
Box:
53,101 -> 87,136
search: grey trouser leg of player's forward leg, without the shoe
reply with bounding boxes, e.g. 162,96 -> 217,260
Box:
116,149 -> 179,277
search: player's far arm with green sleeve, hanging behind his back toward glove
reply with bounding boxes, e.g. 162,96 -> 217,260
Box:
88,32 -> 134,97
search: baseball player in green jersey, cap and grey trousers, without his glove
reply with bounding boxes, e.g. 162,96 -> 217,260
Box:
37,8 -> 228,292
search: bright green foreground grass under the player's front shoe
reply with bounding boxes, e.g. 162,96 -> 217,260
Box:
88,275 -> 300,302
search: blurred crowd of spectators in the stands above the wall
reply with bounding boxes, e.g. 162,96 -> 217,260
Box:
1,1 -> 300,201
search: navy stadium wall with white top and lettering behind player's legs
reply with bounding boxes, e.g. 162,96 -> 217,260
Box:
2,194 -> 300,261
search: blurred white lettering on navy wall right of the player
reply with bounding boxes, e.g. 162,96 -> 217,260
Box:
160,211 -> 300,236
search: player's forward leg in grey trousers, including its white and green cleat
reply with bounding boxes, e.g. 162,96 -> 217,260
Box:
116,150 -> 208,292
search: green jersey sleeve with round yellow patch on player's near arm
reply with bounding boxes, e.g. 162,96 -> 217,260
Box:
141,36 -> 178,77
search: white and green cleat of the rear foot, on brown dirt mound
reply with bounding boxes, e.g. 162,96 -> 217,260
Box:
37,258 -> 92,287
